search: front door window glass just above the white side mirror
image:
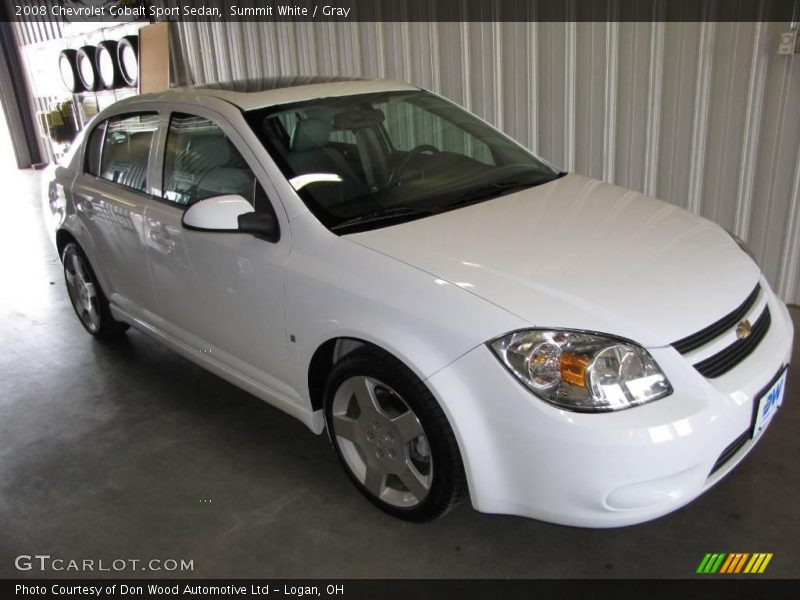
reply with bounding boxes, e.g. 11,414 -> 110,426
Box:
163,113 -> 265,210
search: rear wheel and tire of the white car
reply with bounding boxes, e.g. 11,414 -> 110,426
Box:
61,242 -> 128,339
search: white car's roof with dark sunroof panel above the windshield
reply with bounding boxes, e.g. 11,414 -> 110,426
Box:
118,76 -> 419,110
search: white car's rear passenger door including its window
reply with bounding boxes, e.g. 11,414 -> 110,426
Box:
72,112 -> 159,316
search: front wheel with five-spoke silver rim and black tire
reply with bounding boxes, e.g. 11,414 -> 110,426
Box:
325,346 -> 467,522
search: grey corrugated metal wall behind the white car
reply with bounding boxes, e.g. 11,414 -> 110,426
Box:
12,22 -> 800,303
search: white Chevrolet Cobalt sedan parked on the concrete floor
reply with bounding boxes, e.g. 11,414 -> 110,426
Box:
44,78 -> 793,527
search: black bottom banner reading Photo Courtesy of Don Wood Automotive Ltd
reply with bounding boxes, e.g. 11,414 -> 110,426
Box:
0,575 -> 796,600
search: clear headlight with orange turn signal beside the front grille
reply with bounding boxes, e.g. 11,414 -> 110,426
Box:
488,329 -> 672,412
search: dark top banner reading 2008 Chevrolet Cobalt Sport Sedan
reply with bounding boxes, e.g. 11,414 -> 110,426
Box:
0,0 -> 800,22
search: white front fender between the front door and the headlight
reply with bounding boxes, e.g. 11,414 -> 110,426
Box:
286,213 -> 526,420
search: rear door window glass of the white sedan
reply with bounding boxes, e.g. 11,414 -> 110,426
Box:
100,113 -> 158,192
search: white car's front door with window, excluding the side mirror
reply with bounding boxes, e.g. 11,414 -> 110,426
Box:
145,106 -> 292,396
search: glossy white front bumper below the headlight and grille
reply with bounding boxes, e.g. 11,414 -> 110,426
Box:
428,282 -> 793,527
